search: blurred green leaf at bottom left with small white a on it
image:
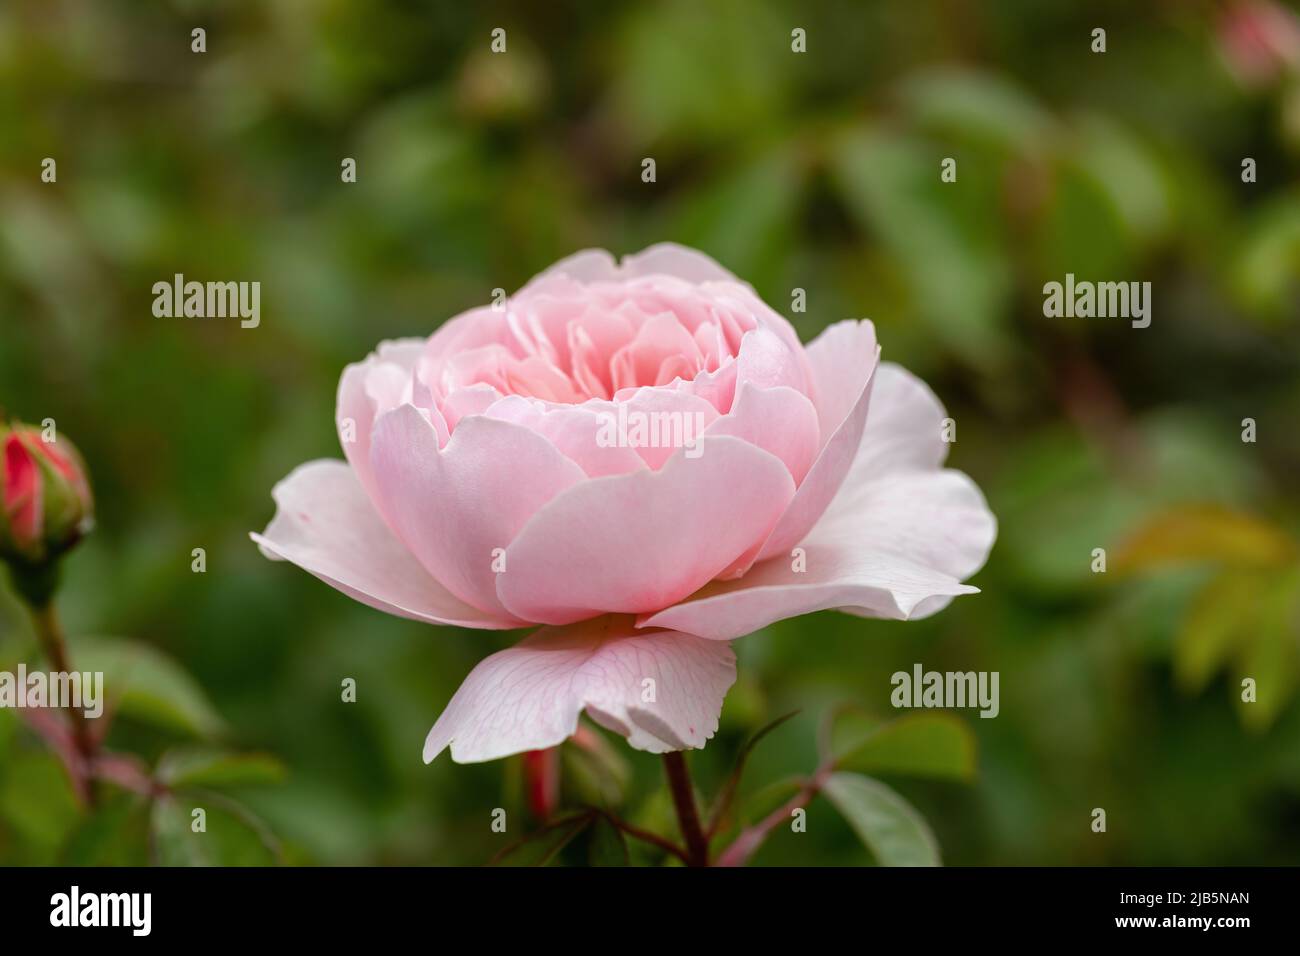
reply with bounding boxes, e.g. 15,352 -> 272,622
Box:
151,791 -> 280,866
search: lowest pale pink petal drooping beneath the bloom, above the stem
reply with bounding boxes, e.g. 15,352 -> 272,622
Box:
424,617 -> 736,763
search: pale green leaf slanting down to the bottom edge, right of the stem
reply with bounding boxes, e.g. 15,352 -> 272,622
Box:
822,774 -> 940,866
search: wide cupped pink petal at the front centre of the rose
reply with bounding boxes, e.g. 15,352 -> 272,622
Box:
497,436 -> 794,624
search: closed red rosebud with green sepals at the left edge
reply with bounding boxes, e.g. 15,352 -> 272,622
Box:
0,423 -> 94,570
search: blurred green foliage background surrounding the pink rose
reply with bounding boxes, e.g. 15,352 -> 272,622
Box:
0,0 -> 1300,865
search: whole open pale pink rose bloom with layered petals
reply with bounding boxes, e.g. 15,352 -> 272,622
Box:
252,245 -> 996,762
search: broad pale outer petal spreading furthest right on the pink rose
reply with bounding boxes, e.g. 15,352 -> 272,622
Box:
637,367 -> 997,640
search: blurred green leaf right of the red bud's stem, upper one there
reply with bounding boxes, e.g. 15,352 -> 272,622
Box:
69,637 -> 225,737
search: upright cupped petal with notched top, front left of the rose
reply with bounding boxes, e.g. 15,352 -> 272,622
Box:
371,405 -> 586,620
